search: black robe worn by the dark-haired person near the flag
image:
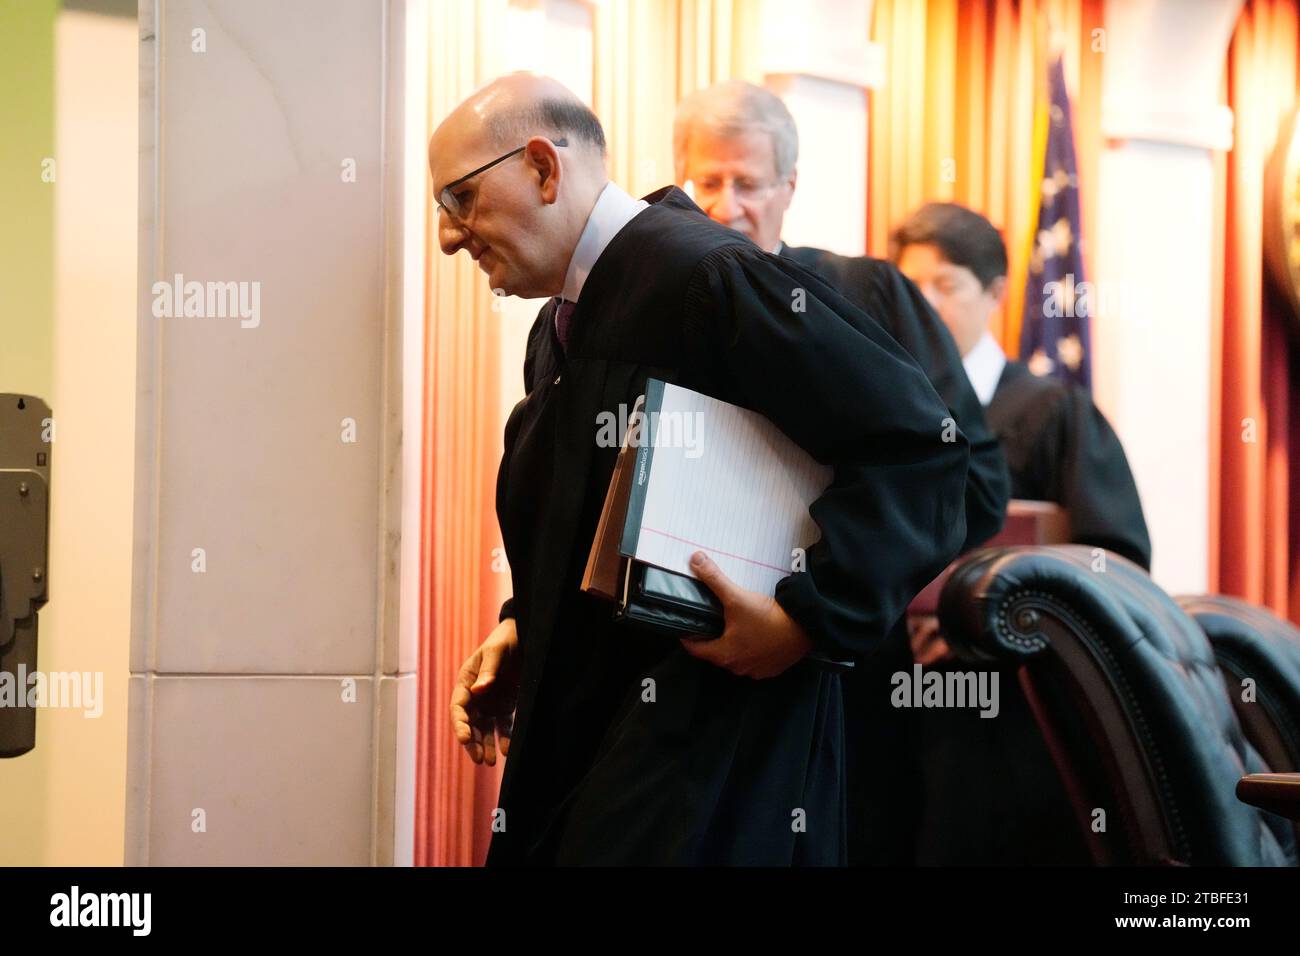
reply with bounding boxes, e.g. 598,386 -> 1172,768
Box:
918,362 -> 1151,866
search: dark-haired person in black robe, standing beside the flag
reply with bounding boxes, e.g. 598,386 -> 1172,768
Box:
892,203 -> 1151,865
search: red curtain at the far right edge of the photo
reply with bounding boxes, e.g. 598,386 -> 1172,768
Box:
1210,0 -> 1300,623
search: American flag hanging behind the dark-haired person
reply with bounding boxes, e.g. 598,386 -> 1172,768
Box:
1021,56 -> 1095,388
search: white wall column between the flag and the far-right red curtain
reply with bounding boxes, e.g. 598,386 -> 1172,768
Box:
1093,0 -> 1242,594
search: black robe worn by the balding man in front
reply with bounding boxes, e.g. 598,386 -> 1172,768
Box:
488,187 -> 969,865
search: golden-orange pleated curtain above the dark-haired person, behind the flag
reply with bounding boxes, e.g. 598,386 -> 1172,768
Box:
867,0 -> 1104,355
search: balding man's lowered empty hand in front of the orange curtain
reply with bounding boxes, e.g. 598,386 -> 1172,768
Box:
451,618 -> 520,766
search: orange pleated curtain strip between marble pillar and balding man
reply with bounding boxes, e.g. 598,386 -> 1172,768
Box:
415,0 -> 510,866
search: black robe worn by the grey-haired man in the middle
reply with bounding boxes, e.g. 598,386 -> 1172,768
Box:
780,246 -> 1010,865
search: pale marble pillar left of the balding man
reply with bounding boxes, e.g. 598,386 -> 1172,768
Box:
126,0 -> 416,865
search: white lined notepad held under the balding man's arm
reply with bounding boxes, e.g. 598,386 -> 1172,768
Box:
620,378 -> 832,594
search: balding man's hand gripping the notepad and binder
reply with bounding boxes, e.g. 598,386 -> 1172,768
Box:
681,551 -> 813,679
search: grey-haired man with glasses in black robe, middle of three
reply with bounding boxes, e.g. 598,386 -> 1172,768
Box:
673,79 -> 1010,865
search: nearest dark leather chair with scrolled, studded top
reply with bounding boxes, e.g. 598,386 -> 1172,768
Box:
939,545 -> 1296,866
